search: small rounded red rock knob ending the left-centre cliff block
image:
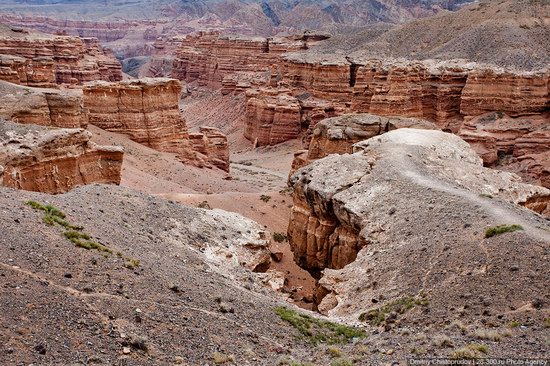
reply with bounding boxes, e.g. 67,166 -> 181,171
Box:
189,126 -> 229,172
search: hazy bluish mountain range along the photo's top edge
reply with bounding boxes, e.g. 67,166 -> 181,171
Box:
0,0 -> 471,34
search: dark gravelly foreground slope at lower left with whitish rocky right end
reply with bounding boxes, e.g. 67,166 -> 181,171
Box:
0,185 -> 326,365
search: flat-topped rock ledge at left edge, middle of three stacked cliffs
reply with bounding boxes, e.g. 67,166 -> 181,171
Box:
0,81 -> 88,128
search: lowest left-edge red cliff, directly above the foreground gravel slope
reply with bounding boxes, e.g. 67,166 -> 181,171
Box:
0,120 -> 123,194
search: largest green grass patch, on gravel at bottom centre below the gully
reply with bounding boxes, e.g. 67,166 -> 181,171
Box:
275,307 -> 367,346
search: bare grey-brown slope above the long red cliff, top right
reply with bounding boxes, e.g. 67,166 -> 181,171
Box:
314,0 -> 550,69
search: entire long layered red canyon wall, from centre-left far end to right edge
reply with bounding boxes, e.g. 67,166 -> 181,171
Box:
172,28 -> 550,186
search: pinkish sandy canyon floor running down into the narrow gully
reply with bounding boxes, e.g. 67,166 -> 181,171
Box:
89,126 -> 314,308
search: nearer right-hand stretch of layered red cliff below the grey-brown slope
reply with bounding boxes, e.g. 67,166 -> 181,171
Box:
245,54 -> 550,187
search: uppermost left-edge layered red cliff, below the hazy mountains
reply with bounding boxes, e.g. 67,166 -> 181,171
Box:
0,26 -> 122,87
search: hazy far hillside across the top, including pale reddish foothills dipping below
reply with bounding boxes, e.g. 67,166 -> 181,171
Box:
0,0 -> 476,57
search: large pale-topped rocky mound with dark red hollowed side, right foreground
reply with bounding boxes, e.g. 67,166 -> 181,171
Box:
288,129 -> 550,320
